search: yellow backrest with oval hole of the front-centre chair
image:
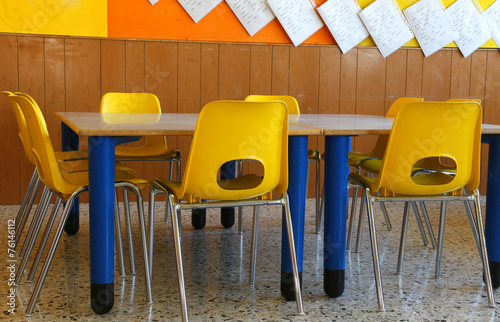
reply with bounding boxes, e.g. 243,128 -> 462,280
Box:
178,101 -> 288,200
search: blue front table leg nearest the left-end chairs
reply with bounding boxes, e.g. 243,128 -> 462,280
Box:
88,136 -> 115,314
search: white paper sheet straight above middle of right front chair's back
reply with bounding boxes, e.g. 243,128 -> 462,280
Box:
403,0 -> 458,57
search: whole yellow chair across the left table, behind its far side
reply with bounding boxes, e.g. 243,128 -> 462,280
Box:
100,92 -> 181,180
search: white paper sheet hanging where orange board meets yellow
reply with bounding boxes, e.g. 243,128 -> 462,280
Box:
318,0 -> 370,54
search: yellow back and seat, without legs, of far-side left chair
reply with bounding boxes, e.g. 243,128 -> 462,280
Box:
100,92 -> 171,157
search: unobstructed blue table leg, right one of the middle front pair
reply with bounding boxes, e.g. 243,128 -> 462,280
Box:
323,136 -> 350,297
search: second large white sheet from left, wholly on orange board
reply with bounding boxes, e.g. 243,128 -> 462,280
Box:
226,0 -> 274,36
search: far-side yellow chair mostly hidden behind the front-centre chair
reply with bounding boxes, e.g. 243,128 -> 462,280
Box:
244,95 -> 321,233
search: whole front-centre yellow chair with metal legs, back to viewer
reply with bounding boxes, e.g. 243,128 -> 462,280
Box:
149,101 -> 304,320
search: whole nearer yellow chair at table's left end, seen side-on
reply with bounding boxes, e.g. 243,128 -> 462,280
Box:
9,95 -> 152,316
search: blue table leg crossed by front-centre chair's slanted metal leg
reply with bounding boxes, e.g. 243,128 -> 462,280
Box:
281,136 -> 308,301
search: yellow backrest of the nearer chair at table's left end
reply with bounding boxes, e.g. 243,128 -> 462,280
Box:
12,95 -> 74,194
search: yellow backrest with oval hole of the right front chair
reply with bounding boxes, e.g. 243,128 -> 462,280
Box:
373,102 -> 482,195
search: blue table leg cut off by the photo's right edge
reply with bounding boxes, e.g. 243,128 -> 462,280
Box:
484,136 -> 500,288
